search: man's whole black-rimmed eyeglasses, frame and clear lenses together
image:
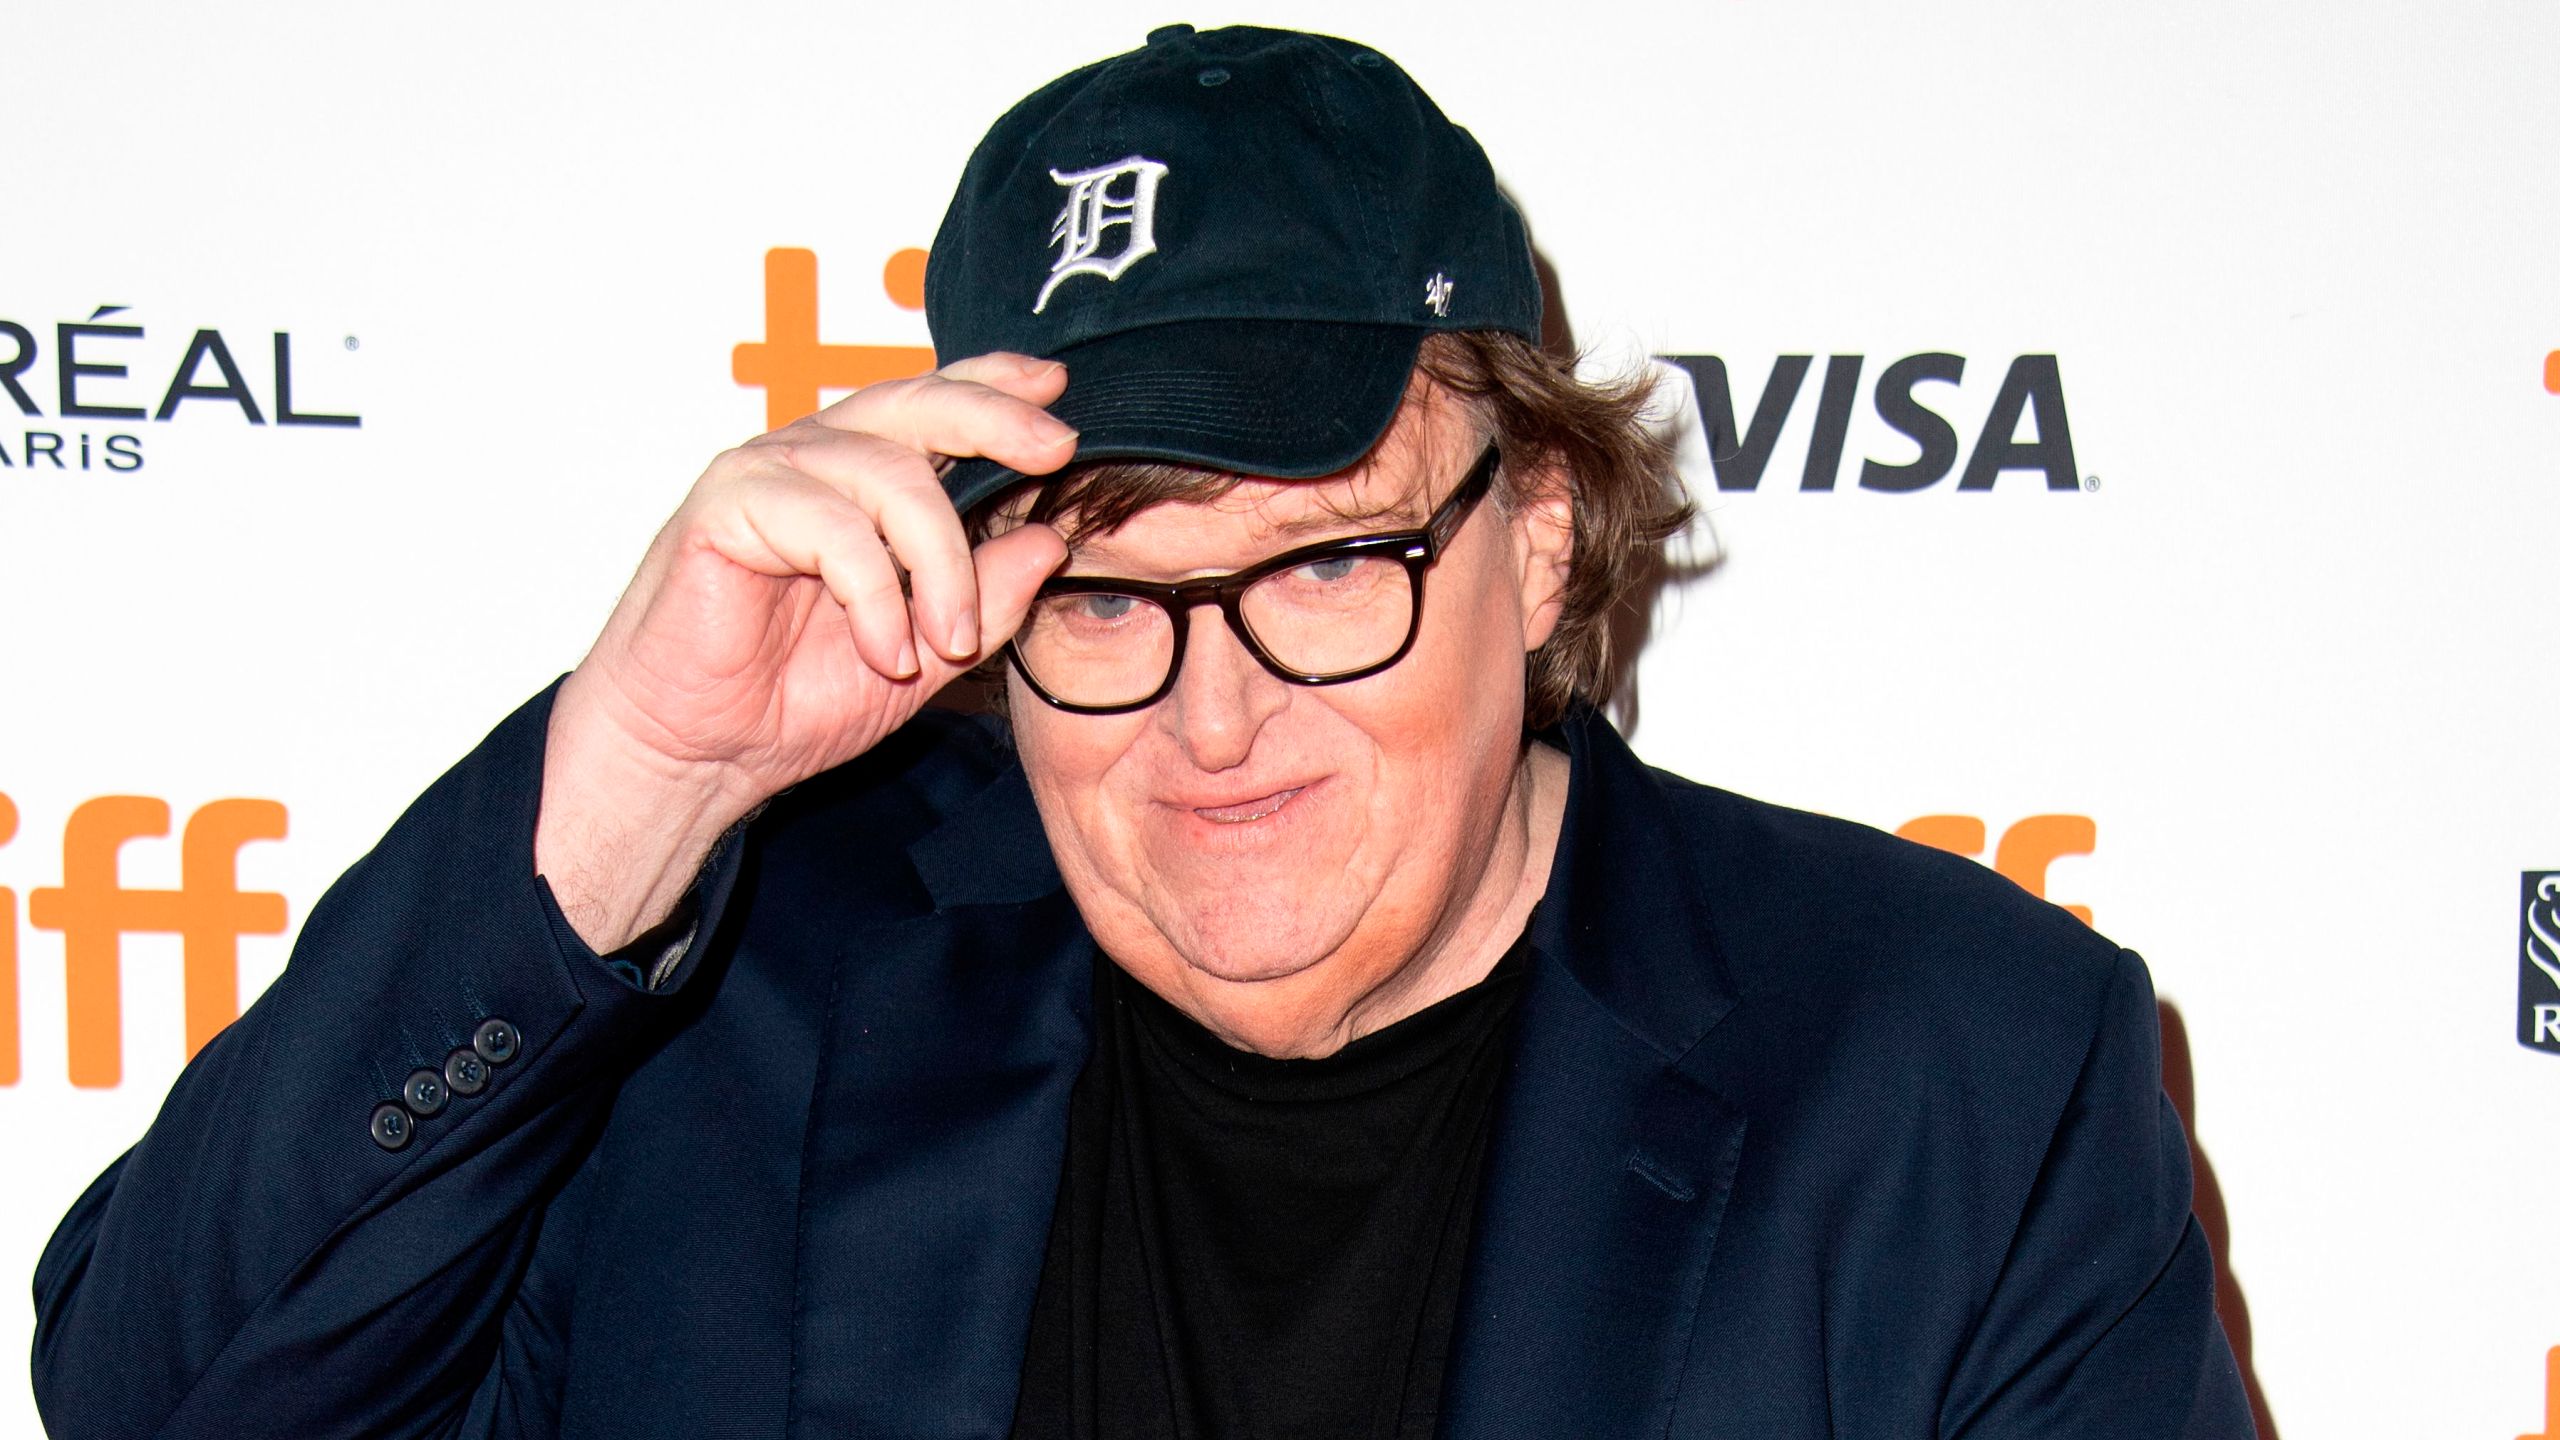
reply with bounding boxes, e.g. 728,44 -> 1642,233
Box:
1006,446 -> 1503,715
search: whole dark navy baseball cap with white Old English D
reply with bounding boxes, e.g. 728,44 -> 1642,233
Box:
924,26 -> 1541,510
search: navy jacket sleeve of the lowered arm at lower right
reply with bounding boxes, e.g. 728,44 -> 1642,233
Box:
1938,953 -> 2255,1440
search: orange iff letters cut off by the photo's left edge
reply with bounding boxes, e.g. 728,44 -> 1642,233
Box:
0,794 -> 284,1089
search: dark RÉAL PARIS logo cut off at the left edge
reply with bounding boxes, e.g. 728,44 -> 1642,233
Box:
0,305 -> 364,471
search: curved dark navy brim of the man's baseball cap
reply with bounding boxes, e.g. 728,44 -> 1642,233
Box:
942,320 -> 1423,512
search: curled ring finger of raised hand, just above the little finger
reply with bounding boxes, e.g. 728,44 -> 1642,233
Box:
752,425 -> 978,661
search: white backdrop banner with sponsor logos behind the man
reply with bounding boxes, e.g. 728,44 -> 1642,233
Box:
0,0 -> 2560,1440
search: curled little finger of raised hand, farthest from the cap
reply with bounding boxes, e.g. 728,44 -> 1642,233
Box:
712,477 -> 916,679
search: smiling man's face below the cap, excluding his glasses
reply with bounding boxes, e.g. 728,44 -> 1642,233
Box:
1011,387 -> 1569,1053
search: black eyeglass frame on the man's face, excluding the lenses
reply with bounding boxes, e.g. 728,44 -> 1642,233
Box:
1004,443 -> 1503,715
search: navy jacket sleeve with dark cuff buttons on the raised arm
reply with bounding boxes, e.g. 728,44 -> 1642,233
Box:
36,692 -> 740,1440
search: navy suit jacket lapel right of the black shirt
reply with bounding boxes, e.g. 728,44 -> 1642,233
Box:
1441,712 -> 1743,1440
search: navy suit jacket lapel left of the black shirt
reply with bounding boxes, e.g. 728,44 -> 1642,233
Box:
788,771 -> 1093,1437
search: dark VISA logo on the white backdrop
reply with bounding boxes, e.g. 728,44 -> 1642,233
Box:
1659,351 -> 2094,495
